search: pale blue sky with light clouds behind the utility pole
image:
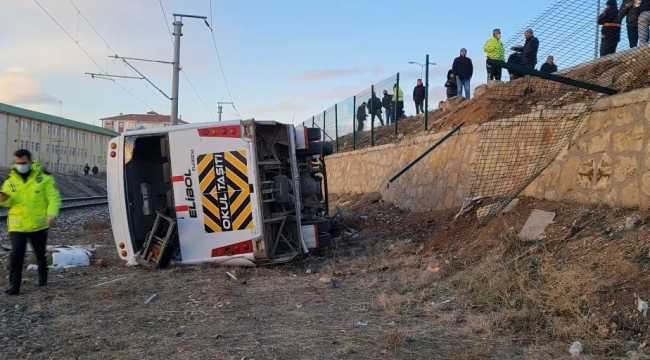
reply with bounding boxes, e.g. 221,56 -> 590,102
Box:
0,0 -> 554,125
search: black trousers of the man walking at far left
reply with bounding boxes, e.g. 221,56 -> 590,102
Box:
9,229 -> 48,289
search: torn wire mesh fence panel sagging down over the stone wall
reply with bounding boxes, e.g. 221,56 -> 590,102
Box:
461,0 -> 650,222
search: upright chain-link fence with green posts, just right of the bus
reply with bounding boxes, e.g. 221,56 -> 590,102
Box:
301,73 -> 404,152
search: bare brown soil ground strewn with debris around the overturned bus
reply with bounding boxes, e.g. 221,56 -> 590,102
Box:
0,194 -> 650,359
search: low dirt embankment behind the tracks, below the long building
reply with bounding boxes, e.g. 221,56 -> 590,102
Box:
0,168 -> 106,198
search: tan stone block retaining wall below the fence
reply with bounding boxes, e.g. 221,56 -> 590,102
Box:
326,89 -> 650,211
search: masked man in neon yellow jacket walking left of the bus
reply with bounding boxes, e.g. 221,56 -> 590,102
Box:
0,149 -> 61,295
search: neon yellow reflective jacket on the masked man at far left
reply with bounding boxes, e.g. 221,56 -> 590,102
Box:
0,161 -> 61,232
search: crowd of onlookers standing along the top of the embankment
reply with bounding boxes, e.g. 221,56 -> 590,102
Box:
356,0 -> 650,131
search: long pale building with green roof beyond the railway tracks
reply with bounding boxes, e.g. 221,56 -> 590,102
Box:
0,103 -> 119,173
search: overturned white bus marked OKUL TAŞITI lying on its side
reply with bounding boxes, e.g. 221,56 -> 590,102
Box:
107,120 -> 338,267
